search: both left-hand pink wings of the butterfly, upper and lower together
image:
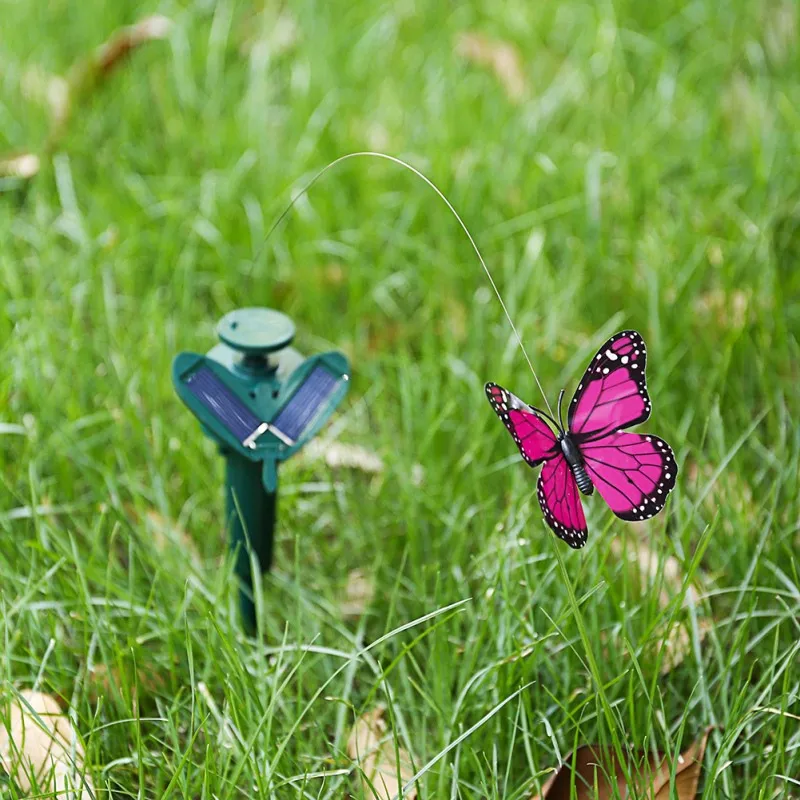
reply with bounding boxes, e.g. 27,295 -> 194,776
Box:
486,383 -> 586,548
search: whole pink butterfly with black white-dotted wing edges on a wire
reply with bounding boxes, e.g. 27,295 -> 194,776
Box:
486,331 -> 678,548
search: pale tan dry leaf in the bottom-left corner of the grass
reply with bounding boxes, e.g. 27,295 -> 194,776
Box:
0,690 -> 96,800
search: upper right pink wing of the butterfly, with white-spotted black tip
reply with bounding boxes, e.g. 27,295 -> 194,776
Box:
568,331 -> 651,450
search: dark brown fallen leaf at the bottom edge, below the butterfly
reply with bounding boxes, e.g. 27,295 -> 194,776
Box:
531,728 -> 711,800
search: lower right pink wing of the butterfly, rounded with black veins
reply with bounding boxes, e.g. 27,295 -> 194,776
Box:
580,431 -> 678,522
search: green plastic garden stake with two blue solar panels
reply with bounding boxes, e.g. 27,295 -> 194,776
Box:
172,308 -> 350,635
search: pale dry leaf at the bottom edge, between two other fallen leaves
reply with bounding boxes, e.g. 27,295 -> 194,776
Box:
347,706 -> 417,800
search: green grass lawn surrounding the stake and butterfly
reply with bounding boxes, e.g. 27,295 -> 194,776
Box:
0,0 -> 800,800
